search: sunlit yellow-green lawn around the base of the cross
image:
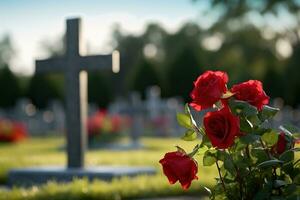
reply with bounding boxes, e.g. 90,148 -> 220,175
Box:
0,137 -> 217,200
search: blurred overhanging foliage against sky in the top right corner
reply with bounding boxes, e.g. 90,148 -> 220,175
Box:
193,0 -> 300,31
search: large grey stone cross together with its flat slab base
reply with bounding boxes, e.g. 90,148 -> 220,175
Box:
9,19 -> 154,185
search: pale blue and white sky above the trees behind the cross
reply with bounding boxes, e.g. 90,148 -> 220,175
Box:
0,0 -> 209,74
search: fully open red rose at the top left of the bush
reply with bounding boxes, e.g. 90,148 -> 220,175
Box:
190,71 -> 228,111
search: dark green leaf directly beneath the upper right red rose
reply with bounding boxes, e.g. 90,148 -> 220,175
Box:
229,100 -> 258,117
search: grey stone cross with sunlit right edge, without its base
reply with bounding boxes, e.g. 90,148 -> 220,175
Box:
36,18 -> 120,168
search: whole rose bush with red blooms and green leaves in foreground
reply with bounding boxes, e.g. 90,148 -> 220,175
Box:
160,71 -> 300,200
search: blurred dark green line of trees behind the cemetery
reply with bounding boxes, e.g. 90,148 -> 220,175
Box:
0,0 -> 300,108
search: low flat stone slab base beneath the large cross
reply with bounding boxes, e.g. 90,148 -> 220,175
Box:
8,166 -> 156,186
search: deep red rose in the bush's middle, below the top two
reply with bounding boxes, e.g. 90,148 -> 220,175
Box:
203,107 -> 240,149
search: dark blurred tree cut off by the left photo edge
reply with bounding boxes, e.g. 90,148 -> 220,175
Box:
0,65 -> 21,108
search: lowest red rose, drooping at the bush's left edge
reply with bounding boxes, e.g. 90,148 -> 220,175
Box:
159,151 -> 198,189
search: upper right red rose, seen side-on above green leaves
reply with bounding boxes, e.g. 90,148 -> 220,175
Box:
231,80 -> 270,110
